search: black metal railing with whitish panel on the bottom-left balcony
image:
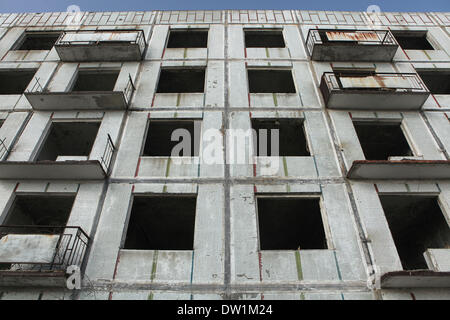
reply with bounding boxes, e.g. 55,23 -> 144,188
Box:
0,225 -> 89,272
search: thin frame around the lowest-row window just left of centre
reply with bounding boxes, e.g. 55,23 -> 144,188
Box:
119,193 -> 198,252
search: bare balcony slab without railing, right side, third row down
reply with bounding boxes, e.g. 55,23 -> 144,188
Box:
347,160 -> 450,180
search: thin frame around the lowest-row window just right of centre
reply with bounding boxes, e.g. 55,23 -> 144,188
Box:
255,193 -> 334,252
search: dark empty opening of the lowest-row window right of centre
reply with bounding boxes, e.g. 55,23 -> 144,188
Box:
257,197 -> 328,250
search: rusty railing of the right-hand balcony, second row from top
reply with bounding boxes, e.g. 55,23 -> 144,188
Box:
322,72 -> 429,92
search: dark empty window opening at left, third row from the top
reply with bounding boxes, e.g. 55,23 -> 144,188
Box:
36,122 -> 100,161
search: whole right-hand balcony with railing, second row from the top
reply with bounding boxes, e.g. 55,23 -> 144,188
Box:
320,72 -> 430,111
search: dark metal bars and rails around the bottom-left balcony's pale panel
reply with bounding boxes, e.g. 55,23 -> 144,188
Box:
0,225 -> 89,272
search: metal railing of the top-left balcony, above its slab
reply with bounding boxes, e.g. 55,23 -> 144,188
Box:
55,29 -> 147,49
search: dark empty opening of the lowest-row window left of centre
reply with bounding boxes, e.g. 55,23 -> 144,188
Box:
124,195 -> 197,250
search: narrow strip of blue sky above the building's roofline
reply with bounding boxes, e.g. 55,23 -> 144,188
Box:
0,0 -> 450,13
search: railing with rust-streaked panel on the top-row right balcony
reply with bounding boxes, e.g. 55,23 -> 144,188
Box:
306,29 -> 397,56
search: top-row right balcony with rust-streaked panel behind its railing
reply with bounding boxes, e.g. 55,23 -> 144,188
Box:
306,29 -> 399,62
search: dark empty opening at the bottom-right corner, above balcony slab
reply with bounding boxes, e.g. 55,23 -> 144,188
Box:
380,195 -> 450,270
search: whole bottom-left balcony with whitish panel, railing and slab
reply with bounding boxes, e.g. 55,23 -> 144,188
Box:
0,226 -> 89,286
